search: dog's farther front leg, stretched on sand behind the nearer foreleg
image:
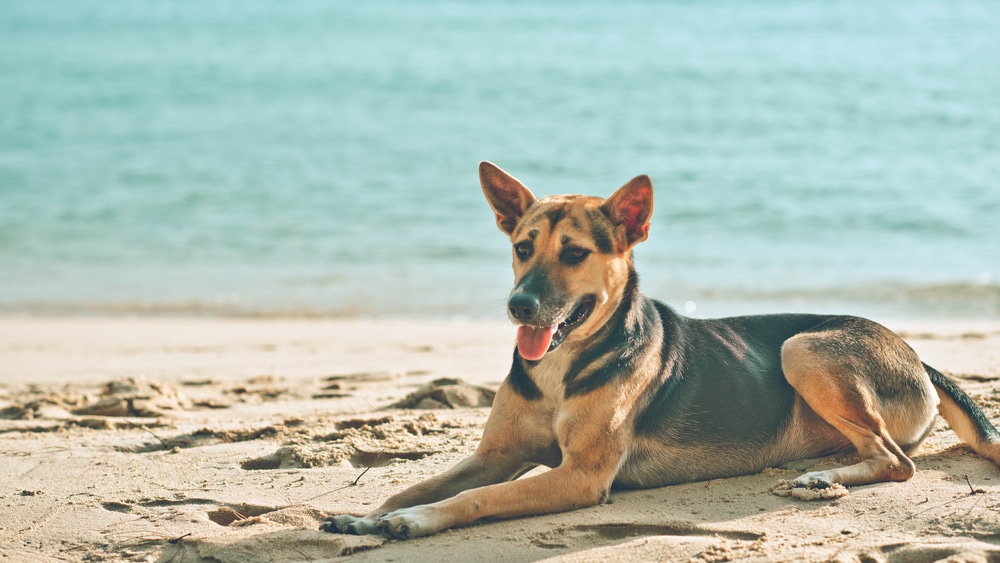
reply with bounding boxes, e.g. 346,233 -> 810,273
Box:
320,451 -> 532,535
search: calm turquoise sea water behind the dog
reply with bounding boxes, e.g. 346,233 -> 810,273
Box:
0,0 -> 1000,318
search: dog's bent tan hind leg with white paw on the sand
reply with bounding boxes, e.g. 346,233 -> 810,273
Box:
782,319 -> 936,488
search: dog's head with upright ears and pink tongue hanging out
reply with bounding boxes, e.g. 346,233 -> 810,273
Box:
479,162 -> 653,360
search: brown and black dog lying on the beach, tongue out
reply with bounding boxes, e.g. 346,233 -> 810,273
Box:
323,162 -> 1000,539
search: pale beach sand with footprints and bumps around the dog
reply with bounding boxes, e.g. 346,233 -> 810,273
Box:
0,318 -> 1000,562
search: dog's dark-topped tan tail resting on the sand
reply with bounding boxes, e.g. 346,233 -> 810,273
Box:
924,364 -> 1000,465
